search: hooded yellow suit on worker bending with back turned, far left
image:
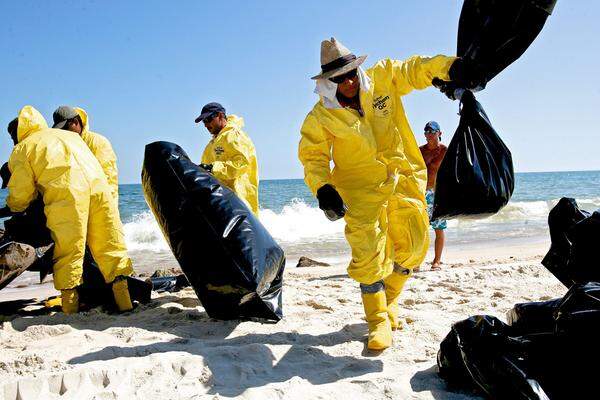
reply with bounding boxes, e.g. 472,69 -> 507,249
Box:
6,106 -> 133,290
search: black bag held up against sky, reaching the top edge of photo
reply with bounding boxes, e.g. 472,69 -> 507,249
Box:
456,0 -> 556,89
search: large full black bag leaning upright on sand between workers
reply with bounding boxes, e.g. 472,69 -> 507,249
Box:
142,142 -> 285,321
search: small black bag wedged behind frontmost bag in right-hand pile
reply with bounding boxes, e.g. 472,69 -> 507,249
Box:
506,299 -> 562,335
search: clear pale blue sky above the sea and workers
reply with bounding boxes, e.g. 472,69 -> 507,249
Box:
0,0 -> 600,183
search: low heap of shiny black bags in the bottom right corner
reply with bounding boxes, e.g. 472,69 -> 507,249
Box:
438,282 -> 600,400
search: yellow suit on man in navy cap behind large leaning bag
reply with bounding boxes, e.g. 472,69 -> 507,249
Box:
201,115 -> 258,215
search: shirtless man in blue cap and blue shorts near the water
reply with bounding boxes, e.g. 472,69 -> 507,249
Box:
419,121 -> 447,270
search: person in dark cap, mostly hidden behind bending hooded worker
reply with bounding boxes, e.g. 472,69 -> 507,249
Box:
52,106 -> 119,205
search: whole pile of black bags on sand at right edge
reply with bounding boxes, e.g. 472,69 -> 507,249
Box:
438,198 -> 600,400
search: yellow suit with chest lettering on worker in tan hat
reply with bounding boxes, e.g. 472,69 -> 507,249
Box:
298,56 -> 455,285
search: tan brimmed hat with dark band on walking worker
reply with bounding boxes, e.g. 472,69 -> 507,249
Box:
310,37 -> 367,79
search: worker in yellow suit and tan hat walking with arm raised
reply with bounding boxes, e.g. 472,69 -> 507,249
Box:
299,38 -> 455,350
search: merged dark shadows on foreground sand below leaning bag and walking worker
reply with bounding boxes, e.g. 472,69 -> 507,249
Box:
5,296 -> 383,396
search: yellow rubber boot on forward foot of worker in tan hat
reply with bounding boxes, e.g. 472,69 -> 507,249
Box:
362,284 -> 392,350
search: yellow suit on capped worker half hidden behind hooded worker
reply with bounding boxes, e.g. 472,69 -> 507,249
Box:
75,107 -> 119,205
